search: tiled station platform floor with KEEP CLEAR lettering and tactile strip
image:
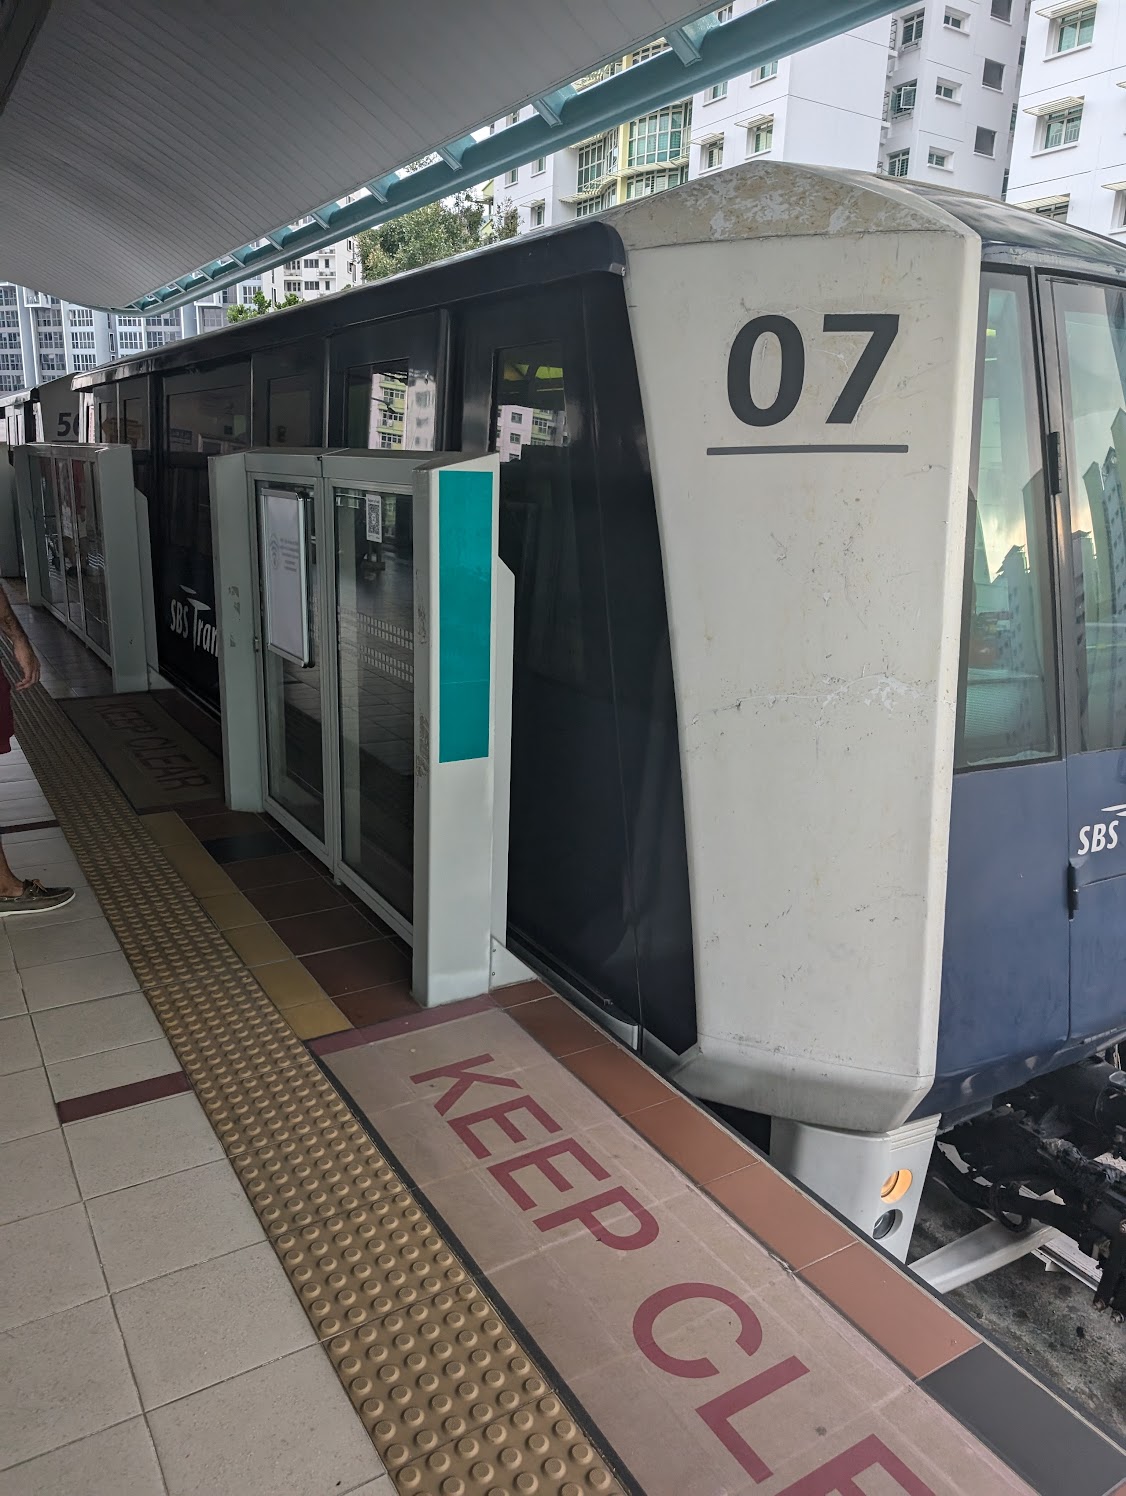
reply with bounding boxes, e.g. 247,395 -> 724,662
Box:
0,604 -> 1126,1496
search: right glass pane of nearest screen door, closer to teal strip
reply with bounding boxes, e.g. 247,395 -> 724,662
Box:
332,485 -> 414,919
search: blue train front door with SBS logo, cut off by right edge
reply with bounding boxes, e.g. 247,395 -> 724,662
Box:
1045,280 -> 1126,1040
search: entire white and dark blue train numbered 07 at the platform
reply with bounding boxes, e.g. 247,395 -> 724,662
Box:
10,163 -> 1126,1309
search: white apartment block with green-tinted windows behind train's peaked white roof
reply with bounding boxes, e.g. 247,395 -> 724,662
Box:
490,0 -> 1029,229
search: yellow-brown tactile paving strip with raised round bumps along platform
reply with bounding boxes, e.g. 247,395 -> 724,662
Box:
8,687 -> 624,1496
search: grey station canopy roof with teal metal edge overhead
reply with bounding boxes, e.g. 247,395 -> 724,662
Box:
0,0 -> 894,313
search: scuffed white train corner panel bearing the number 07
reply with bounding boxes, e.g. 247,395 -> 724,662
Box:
610,168 -> 981,1131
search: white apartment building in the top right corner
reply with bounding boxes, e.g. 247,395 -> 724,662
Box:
1008,0 -> 1126,235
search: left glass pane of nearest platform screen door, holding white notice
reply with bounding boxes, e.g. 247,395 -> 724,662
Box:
254,482 -> 324,841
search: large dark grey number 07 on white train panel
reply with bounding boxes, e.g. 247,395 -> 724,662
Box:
727,311 -> 899,426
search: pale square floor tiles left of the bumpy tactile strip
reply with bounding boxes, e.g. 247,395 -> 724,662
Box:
0,749 -> 393,1496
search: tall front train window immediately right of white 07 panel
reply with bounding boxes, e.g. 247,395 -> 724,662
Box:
956,274 -> 1059,769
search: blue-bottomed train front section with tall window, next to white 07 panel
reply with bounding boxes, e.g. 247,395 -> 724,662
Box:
938,271 -> 1064,1109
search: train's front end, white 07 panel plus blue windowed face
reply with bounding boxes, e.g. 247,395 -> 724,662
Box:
615,163 -> 1126,1298
